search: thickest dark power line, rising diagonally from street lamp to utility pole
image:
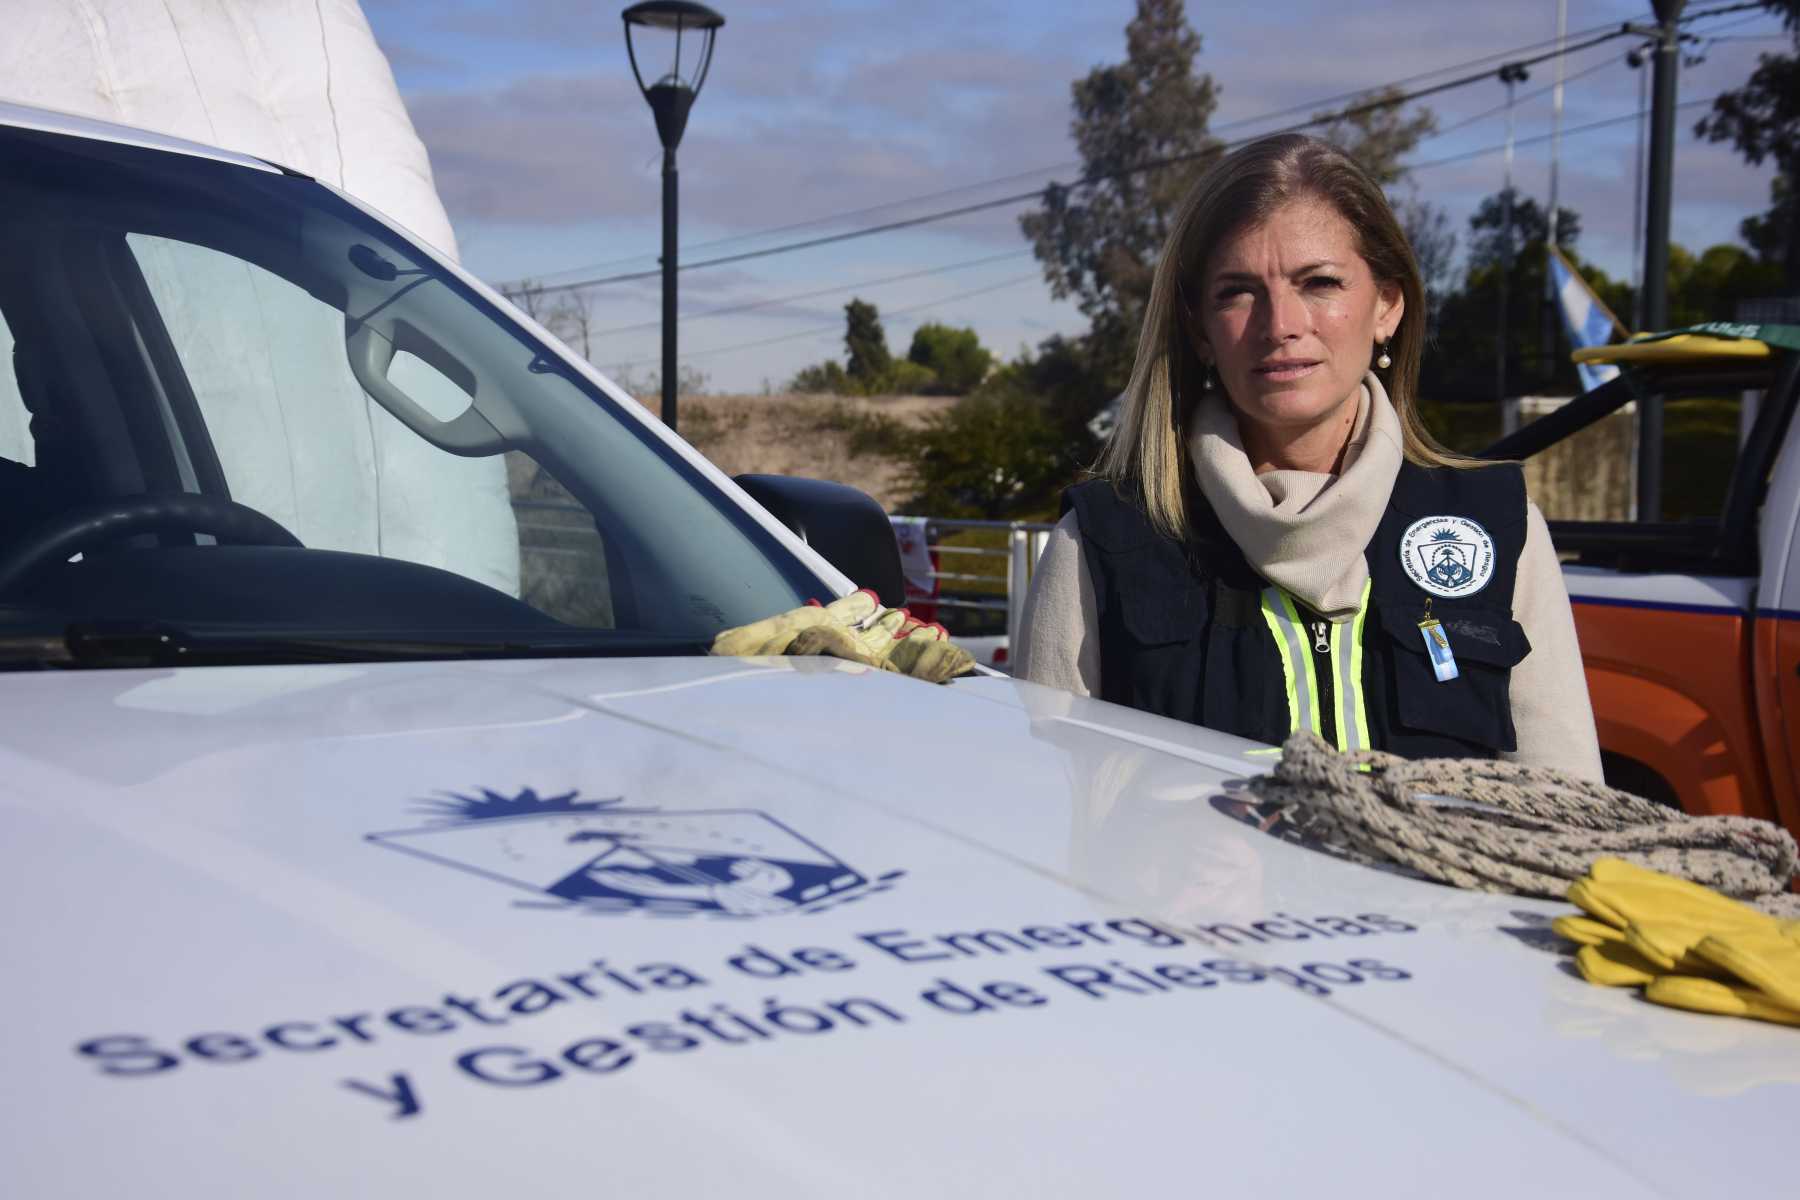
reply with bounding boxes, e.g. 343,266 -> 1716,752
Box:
500,0 -> 1764,291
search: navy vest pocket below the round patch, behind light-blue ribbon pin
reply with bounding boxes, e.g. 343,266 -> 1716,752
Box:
1379,603 -> 1532,754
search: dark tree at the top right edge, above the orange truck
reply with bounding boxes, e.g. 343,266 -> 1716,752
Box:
1694,0 -> 1800,288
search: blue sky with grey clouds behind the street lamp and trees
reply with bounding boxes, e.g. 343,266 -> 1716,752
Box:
364,0 -> 1786,390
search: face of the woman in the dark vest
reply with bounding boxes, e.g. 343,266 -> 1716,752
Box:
1183,198 -> 1404,449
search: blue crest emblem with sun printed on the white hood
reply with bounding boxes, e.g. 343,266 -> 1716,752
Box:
365,788 -> 904,918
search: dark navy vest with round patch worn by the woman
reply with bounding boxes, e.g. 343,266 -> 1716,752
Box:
1062,462 -> 1530,757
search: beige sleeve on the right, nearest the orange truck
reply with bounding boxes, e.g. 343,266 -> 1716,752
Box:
1505,504 -> 1600,779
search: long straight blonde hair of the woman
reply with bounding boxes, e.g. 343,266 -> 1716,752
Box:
1094,133 -> 1478,538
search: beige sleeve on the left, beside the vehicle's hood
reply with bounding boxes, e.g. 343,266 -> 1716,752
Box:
1013,513 -> 1100,696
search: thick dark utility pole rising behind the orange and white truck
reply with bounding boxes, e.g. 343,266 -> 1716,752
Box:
1638,0 -> 1687,522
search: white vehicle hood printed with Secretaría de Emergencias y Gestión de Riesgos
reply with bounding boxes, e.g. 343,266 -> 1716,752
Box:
0,658 -> 1800,1198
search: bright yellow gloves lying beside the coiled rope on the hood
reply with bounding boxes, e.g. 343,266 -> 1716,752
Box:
1552,858 -> 1800,1025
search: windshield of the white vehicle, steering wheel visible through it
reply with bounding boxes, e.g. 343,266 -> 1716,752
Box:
0,128 -> 824,665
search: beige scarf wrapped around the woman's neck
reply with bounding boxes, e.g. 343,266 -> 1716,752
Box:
1188,372 -> 1404,621
